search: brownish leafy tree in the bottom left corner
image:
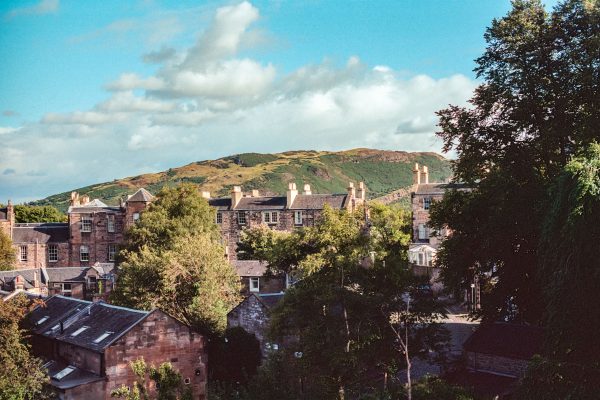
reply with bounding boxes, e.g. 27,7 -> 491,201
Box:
0,295 -> 51,400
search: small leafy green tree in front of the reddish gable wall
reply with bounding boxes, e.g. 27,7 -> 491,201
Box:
111,358 -> 192,400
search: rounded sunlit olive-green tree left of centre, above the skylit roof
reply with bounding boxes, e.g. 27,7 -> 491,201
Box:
111,185 -> 240,335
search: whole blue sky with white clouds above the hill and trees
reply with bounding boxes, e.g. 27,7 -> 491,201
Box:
0,0 -> 554,203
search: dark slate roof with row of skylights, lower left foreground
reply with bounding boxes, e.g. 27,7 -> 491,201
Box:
28,295 -> 153,352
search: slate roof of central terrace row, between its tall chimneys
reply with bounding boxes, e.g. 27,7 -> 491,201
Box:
208,194 -> 348,211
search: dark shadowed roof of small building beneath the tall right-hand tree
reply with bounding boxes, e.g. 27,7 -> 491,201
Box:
464,322 -> 543,360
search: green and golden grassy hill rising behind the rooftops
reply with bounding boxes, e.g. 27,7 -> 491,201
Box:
34,149 -> 450,211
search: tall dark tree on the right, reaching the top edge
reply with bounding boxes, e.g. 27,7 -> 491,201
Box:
432,0 -> 600,322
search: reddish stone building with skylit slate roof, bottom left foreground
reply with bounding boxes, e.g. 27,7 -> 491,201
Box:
27,295 -> 206,400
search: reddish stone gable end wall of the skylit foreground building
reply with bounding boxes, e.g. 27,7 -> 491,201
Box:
105,310 -> 207,400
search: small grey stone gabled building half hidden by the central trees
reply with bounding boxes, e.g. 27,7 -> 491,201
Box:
227,293 -> 283,355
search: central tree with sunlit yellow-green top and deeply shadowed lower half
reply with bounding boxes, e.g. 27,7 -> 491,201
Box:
241,206 -> 440,398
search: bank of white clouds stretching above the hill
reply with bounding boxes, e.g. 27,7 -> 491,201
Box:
0,2 -> 476,200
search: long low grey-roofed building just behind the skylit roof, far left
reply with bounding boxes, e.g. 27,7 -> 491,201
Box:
0,263 -> 115,300
